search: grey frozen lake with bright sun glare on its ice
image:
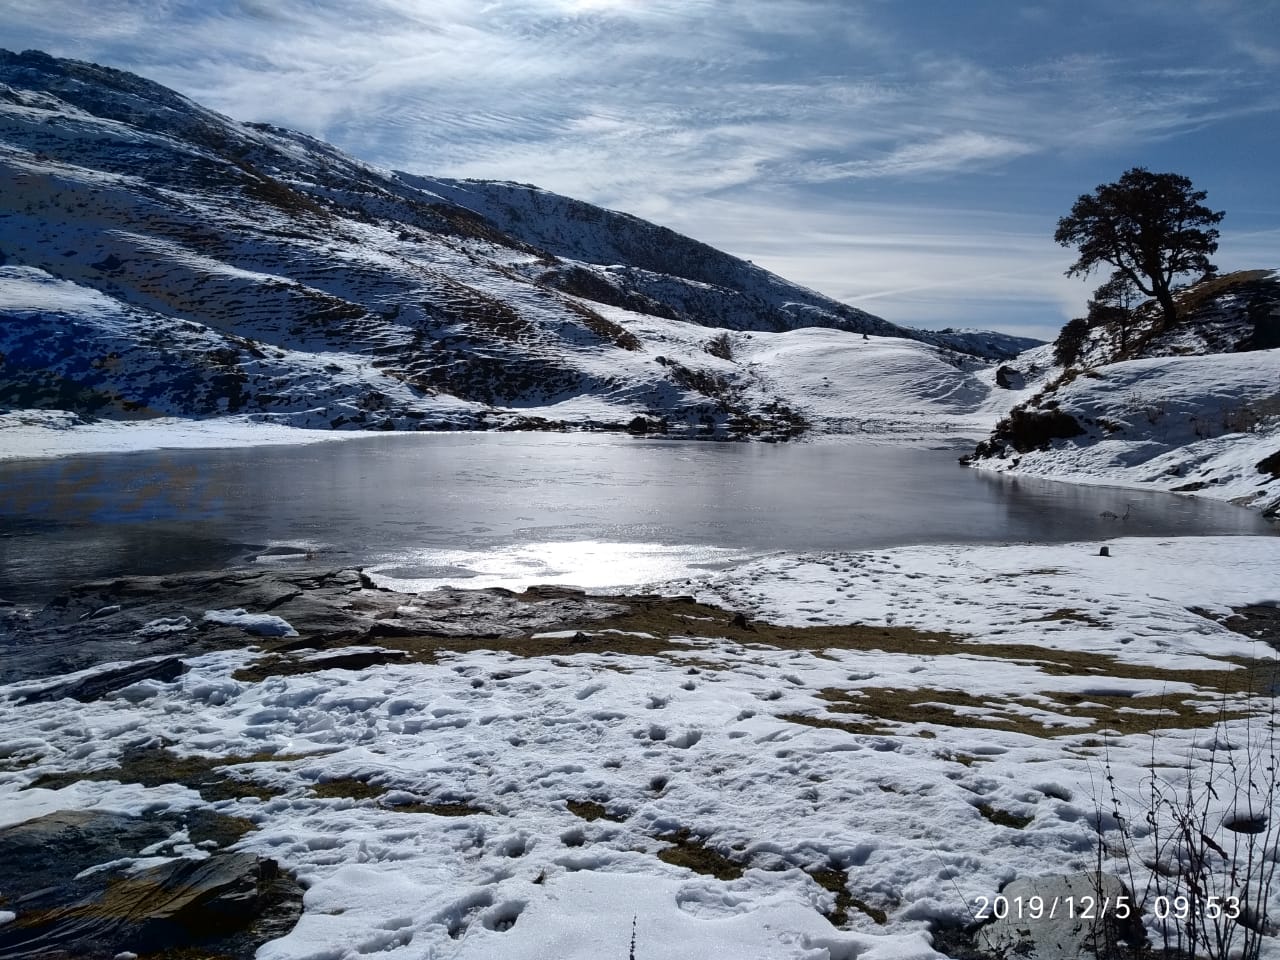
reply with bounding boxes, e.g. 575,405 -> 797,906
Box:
0,434 -> 1274,602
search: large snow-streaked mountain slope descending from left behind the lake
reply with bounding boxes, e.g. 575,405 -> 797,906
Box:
0,51 -> 1030,436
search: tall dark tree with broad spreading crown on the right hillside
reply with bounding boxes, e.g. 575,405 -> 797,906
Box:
1053,166 -> 1224,325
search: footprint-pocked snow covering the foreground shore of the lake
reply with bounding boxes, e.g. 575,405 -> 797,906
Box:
0,538 -> 1280,960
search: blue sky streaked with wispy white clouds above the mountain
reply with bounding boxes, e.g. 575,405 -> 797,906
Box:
0,0 -> 1280,337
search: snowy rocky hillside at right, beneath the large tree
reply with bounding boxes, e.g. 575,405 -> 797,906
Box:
969,270 -> 1280,516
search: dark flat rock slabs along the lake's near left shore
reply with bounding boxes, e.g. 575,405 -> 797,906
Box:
0,564 -> 623,699
